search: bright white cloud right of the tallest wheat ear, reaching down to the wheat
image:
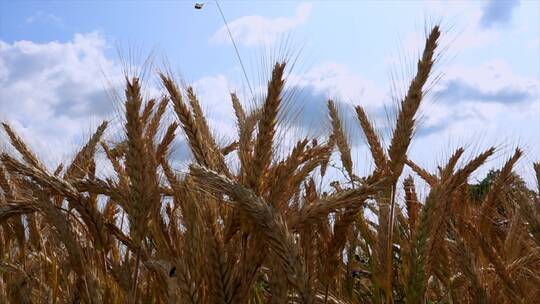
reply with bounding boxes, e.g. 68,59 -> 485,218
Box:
411,60 -> 540,182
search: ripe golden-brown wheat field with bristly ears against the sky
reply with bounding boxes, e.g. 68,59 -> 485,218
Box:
0,26 -> 540,304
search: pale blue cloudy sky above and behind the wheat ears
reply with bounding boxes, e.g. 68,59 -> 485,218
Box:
0,0 -> 540,186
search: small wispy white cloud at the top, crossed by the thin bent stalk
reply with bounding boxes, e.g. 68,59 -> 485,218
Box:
210,3 -> 312,46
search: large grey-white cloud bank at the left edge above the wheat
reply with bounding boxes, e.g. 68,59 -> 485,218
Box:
0,33 -> 121,164
